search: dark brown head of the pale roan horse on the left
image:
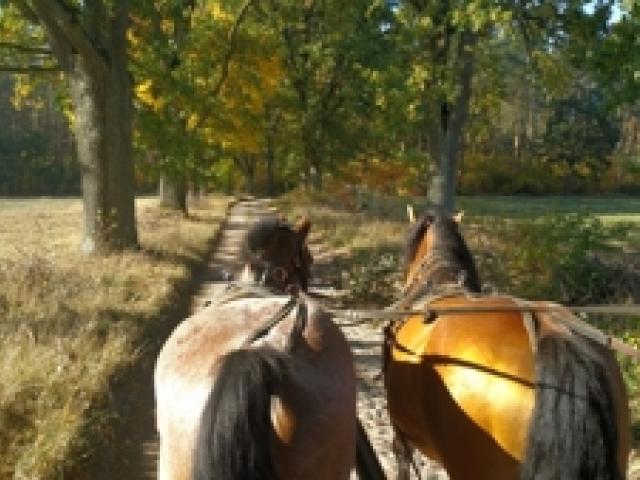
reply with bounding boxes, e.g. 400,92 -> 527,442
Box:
242,217 -> 313,293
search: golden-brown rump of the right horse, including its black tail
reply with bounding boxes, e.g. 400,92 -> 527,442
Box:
386,296 -> 628,480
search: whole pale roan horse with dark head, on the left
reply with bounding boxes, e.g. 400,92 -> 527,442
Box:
155,218 -> 356,480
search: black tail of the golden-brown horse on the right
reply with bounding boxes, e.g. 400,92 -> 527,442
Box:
520,336 -> 624,480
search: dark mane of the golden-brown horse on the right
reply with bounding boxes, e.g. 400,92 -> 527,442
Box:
405,212 -> 481,292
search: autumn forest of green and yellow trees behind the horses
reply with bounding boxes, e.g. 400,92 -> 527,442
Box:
0,0 -> 640,248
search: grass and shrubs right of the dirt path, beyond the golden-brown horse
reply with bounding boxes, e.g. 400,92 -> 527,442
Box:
281,189 -> 640,448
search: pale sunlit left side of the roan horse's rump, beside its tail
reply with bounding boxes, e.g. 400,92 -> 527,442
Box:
154,298 -> 296,480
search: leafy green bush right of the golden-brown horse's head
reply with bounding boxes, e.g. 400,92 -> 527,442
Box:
478,214 -> 640,304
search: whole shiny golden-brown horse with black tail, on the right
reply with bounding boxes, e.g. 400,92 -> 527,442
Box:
384,214 -> 630,480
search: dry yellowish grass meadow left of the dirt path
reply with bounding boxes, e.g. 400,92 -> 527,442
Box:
0,197 -> 230,479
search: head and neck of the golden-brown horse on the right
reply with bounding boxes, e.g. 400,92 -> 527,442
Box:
406,212 -> 480,292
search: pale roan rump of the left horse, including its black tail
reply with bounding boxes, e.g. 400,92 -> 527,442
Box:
155,297 -> 355,480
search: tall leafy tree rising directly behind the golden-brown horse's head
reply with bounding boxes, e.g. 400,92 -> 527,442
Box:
394,0 -> 612,211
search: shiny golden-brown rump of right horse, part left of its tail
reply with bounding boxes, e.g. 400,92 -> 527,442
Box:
386,297 -> 534,479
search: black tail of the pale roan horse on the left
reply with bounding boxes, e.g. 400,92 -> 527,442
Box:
193,348 -> 290,480
